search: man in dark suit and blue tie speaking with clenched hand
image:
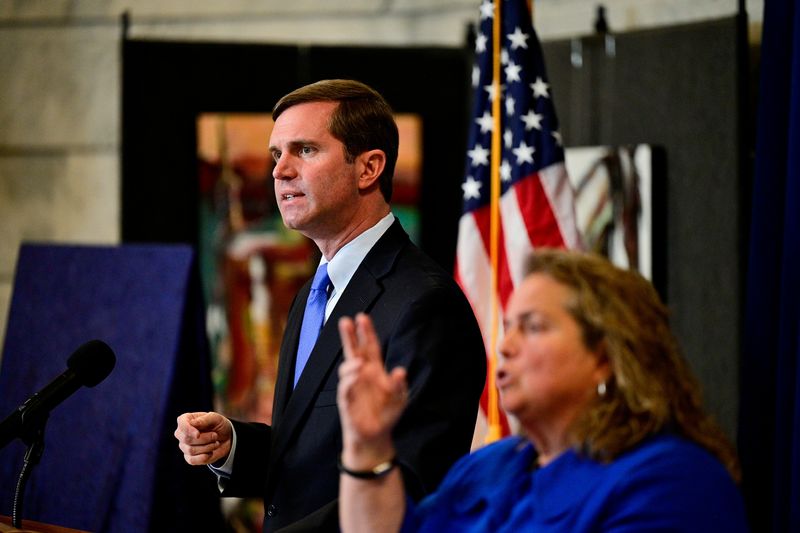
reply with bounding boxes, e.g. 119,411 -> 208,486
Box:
175,80 -> 486,531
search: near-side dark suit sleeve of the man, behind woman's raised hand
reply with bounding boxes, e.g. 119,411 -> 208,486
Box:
382,280 -> 486,499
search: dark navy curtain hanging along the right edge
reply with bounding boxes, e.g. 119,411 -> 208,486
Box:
739,0 -> 800,532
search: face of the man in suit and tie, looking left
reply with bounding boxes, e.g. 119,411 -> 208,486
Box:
269,102 -> 359,244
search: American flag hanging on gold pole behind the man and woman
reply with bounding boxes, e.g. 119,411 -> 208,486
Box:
455,0 -> 582,440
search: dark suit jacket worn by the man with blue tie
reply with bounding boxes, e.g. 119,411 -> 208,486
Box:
223,221 -> 486,531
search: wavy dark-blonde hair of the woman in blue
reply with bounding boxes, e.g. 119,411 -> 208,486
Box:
526,250 -> 740,482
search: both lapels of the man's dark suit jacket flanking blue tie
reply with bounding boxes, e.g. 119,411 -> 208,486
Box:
270,221 -> 408,463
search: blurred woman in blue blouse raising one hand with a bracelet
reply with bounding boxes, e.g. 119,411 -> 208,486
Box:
338,251 -> 747,533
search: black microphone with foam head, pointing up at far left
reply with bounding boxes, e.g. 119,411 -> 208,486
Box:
0,340 -> 117,449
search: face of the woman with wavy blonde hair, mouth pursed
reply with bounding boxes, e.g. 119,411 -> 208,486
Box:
497,274 -> 609,429
